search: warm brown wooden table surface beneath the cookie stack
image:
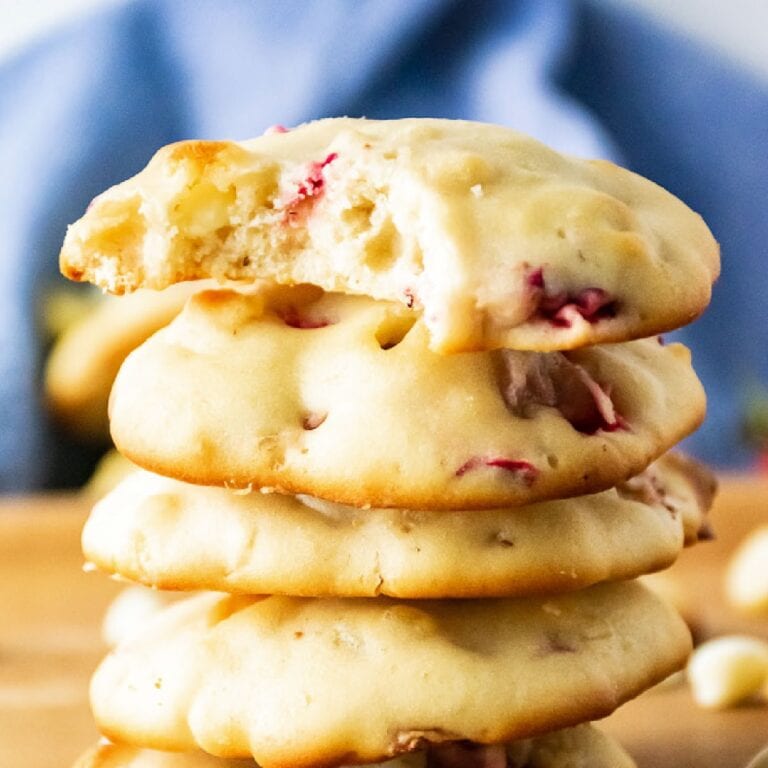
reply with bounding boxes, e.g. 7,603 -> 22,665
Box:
0,478 -> 768,768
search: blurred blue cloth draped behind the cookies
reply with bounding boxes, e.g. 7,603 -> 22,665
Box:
0,0 -> 768,490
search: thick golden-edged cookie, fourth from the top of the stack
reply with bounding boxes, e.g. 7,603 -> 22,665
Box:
91,582 -> 690,768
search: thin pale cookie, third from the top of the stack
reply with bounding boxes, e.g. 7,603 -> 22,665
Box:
83,456 -> 709,605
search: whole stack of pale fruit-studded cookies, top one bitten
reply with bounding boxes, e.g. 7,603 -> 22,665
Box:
62,119 -> 719,768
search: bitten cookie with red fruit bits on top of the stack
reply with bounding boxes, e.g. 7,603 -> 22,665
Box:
61,118 -> 719,352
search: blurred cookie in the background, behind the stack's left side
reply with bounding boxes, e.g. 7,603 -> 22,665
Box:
45,283 -> 205,442
